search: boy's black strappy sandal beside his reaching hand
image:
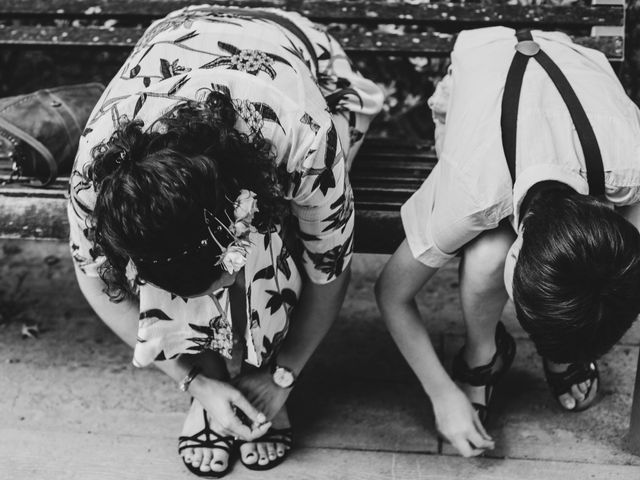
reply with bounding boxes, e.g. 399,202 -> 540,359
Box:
452,322 -> 516,423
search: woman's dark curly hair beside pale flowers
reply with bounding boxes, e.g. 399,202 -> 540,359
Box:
86,92 -> 289,301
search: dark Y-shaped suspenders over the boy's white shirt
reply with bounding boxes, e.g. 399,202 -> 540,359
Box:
500,31 -> 605,195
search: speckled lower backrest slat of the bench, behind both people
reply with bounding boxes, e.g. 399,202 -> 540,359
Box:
0,25 -> 624,60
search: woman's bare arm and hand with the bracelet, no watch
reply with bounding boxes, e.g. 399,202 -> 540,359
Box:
75,265 -> 271,440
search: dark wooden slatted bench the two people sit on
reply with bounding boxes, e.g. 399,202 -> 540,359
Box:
0,0 -> 640,454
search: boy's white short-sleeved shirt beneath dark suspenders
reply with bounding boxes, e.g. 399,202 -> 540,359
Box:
401,27 -> 640,268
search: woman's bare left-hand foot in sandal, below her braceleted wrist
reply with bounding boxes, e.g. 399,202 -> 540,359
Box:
179,398 -> 229,472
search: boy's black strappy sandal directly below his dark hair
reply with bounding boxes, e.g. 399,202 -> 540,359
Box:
542,359 -> 600,412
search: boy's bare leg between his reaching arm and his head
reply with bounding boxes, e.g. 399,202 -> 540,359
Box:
460,223 -> 516,404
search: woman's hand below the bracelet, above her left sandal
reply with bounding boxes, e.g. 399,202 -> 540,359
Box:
189,375 -> 271,441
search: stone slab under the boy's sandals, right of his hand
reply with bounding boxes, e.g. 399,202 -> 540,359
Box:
443,336 -> 640,464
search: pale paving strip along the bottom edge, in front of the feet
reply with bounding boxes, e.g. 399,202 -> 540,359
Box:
0,429 -> 640,480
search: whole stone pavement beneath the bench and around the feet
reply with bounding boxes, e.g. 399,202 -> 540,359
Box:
0,241 -> 640,480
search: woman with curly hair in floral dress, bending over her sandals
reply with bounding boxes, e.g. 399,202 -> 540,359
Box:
68,6 -> 383,478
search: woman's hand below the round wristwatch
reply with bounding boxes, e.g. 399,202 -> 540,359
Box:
232,369 -> 291,418
